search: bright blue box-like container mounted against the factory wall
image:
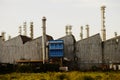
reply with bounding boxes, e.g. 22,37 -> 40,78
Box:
49,40 -> 64,57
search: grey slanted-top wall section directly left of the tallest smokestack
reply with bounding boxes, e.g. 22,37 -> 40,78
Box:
76,34 -> 102,69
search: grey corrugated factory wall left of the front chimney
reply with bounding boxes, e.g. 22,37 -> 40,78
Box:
0,36 -> 53,63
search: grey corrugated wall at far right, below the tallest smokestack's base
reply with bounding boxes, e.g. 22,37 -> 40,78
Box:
103,36 -> 120,63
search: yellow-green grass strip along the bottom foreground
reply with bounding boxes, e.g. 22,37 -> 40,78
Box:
0,71 -> 120,80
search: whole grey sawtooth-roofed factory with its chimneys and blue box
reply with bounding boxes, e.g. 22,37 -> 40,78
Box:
0,6 -> 120,70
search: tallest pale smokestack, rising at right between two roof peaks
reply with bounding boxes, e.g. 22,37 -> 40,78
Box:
101,6 -> 106,41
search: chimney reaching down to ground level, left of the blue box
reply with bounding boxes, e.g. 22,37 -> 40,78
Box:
42,17 -> 46,64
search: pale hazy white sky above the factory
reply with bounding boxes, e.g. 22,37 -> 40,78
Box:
0,0 -> 120,40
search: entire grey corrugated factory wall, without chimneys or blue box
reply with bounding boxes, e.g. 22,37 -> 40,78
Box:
0,34 -> 120,69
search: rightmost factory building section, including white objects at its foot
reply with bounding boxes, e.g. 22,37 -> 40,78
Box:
102,36 -> 120,70
